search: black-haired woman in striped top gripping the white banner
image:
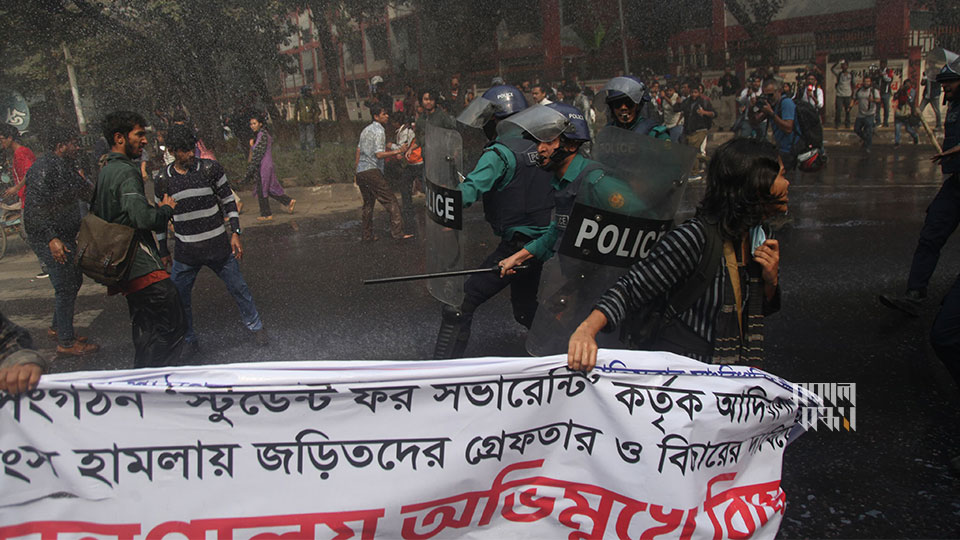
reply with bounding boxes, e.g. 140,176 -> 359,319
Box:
567,139 -> 789,371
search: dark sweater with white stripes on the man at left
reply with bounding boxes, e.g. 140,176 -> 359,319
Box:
154,158 -> 240,266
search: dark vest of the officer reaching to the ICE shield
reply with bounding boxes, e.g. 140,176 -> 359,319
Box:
483,138 -> 553,236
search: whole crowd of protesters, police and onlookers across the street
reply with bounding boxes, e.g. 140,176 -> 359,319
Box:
0,54 -> 960,416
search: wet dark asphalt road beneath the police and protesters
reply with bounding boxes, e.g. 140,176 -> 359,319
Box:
4,145 -> 960,538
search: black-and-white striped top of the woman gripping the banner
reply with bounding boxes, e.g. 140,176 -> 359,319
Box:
594,218 -> 780,362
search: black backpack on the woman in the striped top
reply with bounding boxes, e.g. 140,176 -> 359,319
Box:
620,217 -> 723,356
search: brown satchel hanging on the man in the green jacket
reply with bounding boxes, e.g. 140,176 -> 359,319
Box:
76,212 -> 138,286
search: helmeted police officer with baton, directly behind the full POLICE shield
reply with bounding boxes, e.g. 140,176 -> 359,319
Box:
500,103 -> 642,276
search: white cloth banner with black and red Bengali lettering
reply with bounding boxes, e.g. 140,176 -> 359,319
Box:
0,350 -> 817,540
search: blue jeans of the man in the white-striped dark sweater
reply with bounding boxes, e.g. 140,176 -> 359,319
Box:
170,254 -> 263,343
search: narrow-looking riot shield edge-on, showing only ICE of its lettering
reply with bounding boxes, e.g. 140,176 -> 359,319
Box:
423,124 -> 466,306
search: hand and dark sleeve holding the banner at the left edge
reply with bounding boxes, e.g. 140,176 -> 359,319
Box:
0,313 -> 50,395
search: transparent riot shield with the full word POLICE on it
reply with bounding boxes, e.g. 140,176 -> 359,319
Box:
526,126 -> 697,356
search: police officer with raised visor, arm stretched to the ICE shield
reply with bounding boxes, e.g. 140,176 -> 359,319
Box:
434,85 -> 553,359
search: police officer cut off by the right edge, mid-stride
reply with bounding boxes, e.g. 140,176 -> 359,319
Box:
880,58 -> 960,372
